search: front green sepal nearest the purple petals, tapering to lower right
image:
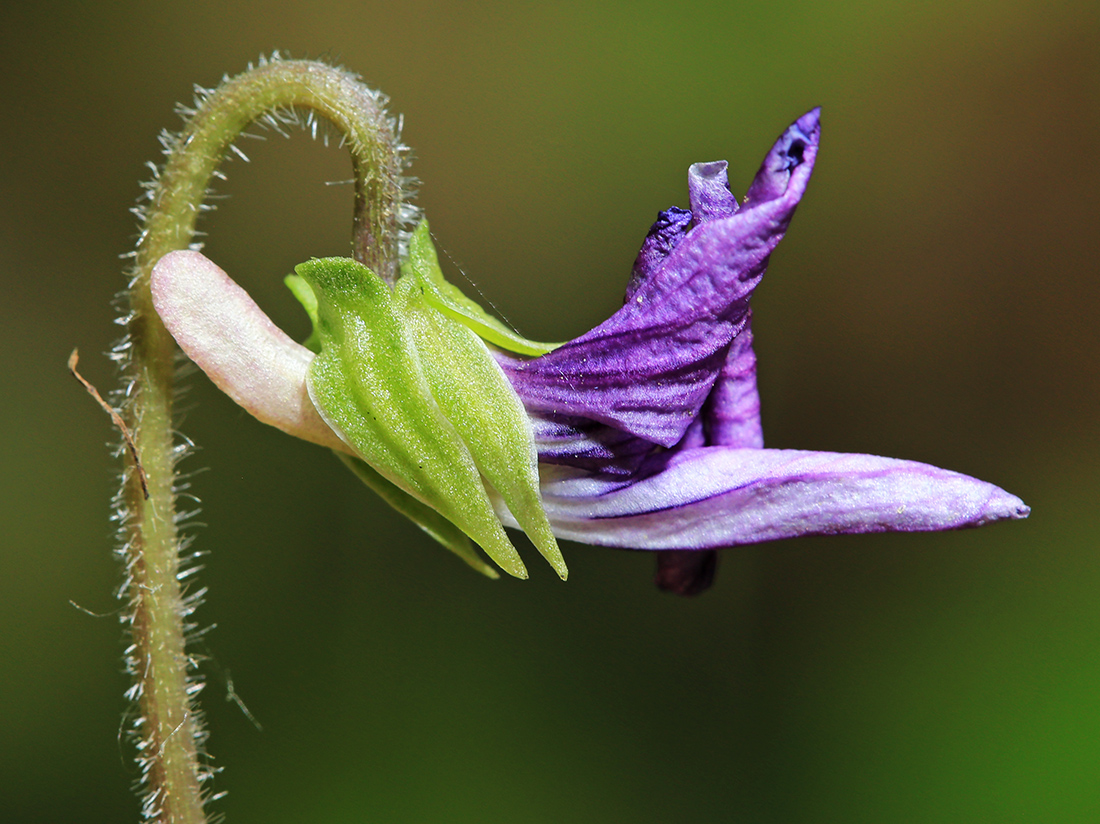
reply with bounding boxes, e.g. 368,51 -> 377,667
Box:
394,273 -> 569,581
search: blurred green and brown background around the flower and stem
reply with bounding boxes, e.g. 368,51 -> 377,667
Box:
0,0 -> 1100,824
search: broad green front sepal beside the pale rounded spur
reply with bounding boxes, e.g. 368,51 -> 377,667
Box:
295,257 -> 527,578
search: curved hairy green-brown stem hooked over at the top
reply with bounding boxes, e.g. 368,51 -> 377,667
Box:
117,61 -> 407,824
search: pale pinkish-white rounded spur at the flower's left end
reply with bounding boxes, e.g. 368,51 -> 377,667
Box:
152,251 -> 350,452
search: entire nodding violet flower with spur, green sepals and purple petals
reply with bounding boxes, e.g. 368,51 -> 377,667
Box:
153,109 -> 1029,594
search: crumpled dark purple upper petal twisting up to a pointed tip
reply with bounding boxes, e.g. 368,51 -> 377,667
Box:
499,112 -> 820,447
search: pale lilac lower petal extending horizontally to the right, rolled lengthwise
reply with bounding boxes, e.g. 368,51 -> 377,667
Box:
528,447 -> 1030,550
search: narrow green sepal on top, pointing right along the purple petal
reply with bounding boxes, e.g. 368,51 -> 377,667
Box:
402,220 -> 561,356
